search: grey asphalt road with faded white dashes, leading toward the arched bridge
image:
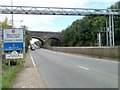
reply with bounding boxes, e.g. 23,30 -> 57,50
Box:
30,49 -> 118,88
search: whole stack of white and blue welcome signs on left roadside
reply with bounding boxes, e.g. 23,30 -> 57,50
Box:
2,28 -> 25,59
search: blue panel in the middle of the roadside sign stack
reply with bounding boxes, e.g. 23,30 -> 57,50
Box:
4,42 -> 23,51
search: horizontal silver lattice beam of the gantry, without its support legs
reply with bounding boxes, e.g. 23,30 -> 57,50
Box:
0,5 -> 120,16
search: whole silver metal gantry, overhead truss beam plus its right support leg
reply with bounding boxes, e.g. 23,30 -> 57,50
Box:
0,5 -> 120,46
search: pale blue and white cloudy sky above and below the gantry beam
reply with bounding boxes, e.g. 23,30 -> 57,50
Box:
0,0 -> 118,32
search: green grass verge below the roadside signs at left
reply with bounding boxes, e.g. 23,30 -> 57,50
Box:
2,55 -> 26,88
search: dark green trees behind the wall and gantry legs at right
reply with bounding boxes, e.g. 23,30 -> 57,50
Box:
61,2 -> 120,46
